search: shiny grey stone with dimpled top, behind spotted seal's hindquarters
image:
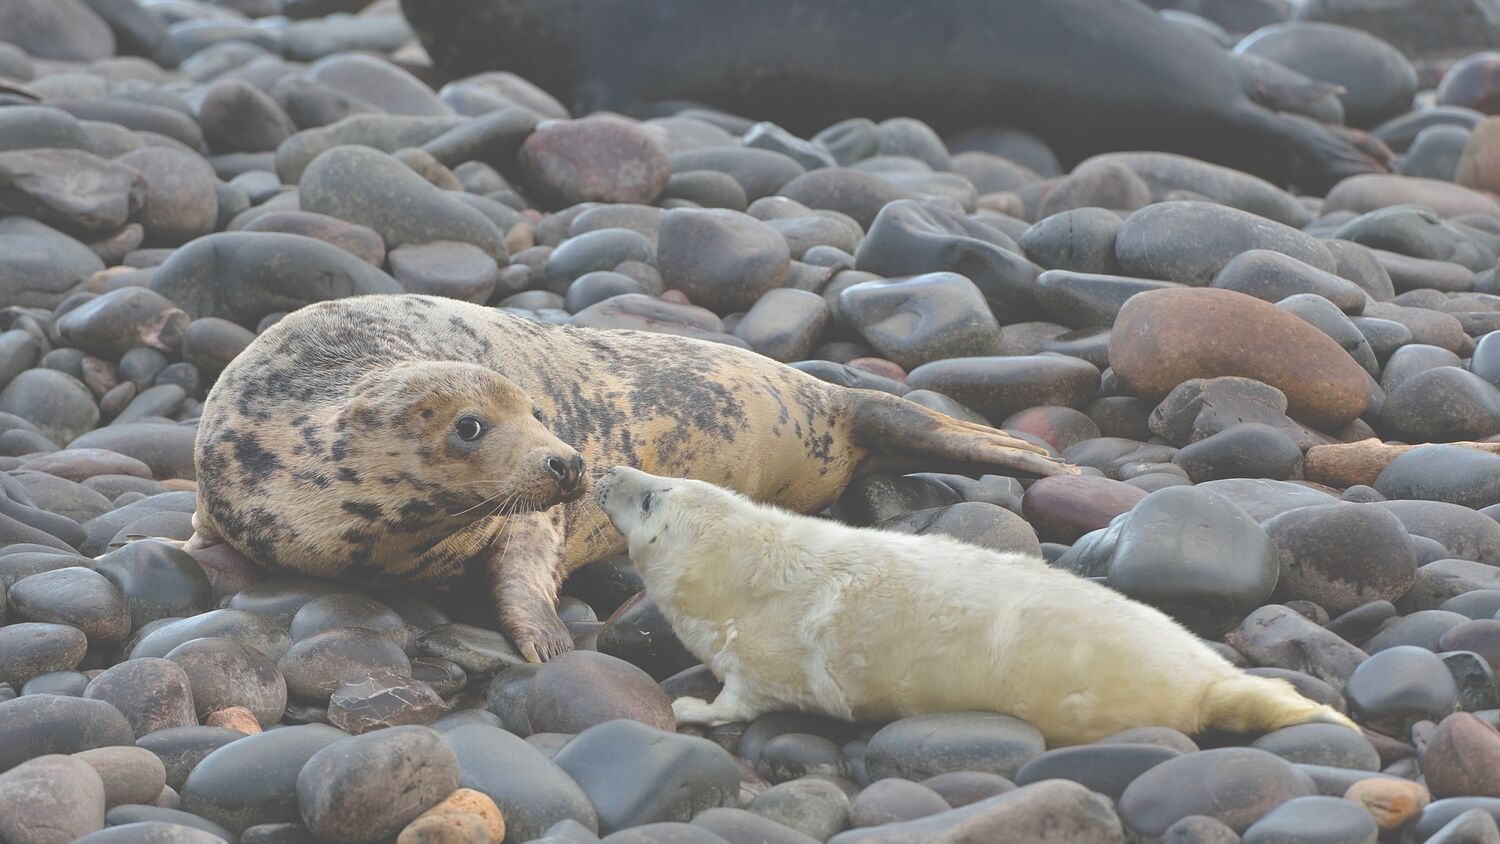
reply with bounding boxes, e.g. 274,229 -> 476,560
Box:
837,273 -> 1001,369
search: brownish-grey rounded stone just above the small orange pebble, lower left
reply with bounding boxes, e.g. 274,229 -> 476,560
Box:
167,639 -> 287,727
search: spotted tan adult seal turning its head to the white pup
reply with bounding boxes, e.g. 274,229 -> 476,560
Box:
189,295 -> 1076,660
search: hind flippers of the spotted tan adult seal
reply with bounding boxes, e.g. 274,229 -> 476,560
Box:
846,390 -> 1079,477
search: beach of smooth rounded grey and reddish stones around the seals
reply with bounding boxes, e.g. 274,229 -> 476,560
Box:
0,0 -> 1500,844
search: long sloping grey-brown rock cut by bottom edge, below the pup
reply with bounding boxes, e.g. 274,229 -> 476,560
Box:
830,781 -> 1125,844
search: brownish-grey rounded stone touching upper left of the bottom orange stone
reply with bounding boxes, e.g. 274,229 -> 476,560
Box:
292,727 -> 459,844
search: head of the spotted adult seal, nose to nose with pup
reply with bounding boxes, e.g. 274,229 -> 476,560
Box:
335,361 -> 588,520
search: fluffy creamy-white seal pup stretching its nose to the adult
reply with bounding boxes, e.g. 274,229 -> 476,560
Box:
594,466 -> 1358,745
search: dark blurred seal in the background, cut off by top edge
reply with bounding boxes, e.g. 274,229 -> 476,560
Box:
402,0 -> 1389,192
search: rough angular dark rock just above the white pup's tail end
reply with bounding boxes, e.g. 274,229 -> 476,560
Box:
1224,604 -> 1367,688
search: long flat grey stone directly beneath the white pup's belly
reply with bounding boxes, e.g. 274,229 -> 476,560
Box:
866,712 -> 1043,780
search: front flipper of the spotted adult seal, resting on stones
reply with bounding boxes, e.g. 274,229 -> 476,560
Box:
485,508 -> 573,663
